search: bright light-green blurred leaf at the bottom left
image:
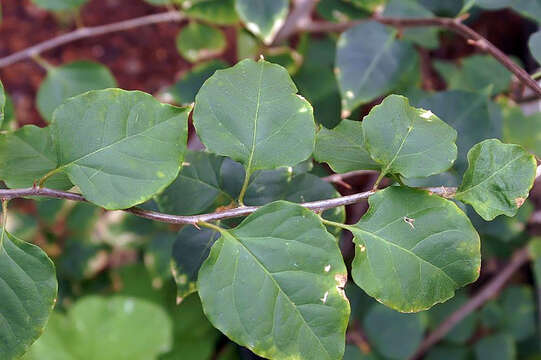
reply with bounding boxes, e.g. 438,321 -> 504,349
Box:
25,296 -> 171,360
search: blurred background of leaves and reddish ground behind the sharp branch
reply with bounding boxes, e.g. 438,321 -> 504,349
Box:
0,0 -> 541,360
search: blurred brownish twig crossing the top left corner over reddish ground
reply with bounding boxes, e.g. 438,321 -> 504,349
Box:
0,11 -> 185,68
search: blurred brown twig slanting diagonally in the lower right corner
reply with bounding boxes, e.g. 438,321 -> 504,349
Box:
411,247 -> 529,360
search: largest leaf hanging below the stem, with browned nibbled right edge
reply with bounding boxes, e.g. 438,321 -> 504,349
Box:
198,201 -> 349,359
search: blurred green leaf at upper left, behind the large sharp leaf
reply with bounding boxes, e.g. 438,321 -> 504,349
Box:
36,61 -> 116,122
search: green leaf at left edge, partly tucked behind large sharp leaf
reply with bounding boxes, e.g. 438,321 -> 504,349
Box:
0,125 -> 72,189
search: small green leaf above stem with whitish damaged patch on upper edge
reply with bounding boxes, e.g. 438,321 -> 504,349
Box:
362,95 -> 457,178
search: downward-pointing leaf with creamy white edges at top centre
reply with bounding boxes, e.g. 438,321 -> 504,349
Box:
235,0 -> 289,45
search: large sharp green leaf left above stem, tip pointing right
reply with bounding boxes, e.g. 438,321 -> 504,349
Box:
51,89 -> 189,209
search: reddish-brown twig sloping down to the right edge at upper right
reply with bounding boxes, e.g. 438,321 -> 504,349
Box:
298,16 -> 541,97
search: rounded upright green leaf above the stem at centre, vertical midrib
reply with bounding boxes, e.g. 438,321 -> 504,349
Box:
193,59 -> 315,176
